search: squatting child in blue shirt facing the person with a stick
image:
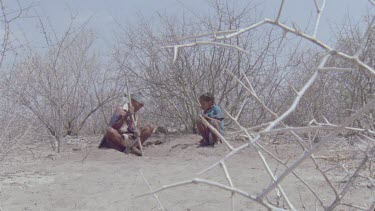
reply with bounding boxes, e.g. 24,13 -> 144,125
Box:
197,93 -> 224,146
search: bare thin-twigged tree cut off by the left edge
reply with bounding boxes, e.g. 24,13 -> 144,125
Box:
0,0 -> 32,160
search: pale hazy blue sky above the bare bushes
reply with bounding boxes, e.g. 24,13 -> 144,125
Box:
5,0 -> 375,52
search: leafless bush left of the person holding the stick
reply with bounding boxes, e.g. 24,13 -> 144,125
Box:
5,17 -> 124,152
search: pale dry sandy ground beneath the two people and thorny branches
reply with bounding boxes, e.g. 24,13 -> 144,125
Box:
0,135 -> 375,211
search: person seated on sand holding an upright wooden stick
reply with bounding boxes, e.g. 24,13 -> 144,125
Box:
99,92 -> 155,155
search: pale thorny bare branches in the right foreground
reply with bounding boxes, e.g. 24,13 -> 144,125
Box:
138,0 -> 375,210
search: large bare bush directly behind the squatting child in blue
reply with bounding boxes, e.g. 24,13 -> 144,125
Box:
116,1 -> 306,131
